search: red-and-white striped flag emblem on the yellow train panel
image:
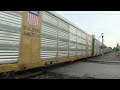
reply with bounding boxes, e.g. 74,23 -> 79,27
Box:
27,11 -> 39,26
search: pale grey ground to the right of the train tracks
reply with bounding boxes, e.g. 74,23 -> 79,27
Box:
50,52 -> 120,79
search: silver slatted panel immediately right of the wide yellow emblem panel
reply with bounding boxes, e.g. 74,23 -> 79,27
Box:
40,12 -> 57,59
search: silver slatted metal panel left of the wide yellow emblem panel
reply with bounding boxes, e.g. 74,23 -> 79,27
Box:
0,11 -> 22,64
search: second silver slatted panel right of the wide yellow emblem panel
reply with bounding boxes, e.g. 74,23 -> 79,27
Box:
58,20 -> 69,57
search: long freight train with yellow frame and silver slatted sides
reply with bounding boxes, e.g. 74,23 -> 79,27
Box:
0,11 -> 111,76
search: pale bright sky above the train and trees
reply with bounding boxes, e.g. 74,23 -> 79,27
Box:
55,11 -> 120,48
